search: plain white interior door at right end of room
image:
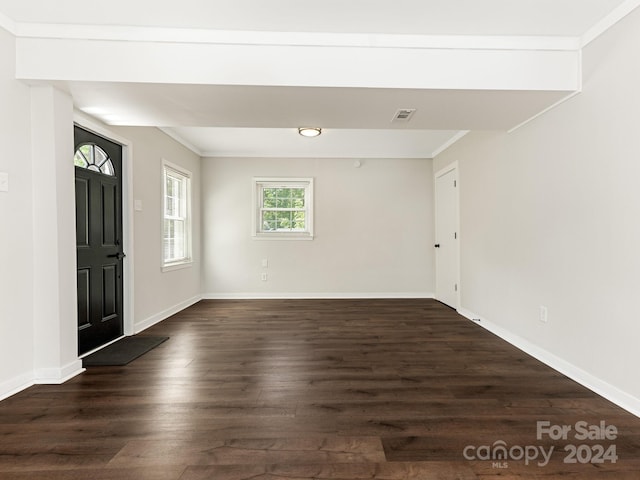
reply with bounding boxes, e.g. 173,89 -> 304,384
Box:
434,167 -> 459,309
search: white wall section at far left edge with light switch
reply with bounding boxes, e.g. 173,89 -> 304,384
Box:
0,24 -> 34,398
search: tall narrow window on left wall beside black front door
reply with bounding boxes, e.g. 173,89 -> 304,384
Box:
162,162 -> 191,271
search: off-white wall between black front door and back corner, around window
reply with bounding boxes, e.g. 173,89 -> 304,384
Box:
109,127 -> 201,332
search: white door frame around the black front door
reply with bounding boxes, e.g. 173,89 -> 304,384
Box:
73,111 -> 135,335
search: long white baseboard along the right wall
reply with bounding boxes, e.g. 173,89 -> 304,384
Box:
458,308 -> 640,417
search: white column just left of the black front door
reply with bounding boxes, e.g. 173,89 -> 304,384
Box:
31,86 -> 82,383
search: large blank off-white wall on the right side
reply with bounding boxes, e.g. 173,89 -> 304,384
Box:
434,6 -> 640,413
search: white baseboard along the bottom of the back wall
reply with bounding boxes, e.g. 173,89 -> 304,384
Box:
202,292 -> 435,300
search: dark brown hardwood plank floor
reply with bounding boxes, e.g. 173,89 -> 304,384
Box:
0,300 -> 640,480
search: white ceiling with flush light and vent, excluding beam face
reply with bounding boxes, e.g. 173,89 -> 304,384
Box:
0,0 -> 629,158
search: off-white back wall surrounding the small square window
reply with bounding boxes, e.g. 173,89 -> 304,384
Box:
202,158 -> 434,297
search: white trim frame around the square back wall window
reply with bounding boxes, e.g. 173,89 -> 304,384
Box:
251,177 -> 313,240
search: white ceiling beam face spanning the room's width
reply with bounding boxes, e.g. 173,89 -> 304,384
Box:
16,37 -> 580,91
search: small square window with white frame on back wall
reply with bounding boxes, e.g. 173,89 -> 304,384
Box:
253,178 -> 313,240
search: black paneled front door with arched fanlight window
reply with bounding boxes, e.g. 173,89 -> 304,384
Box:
74,127 -> 124,355
